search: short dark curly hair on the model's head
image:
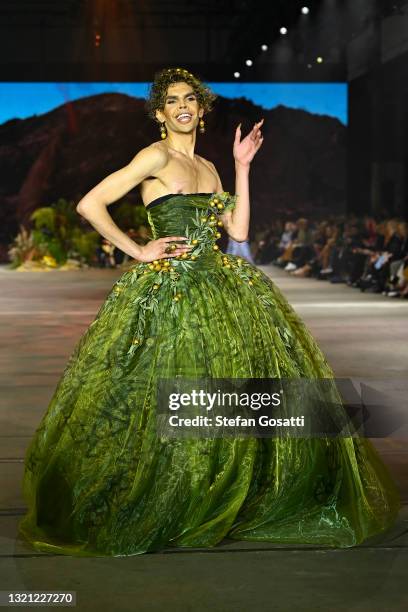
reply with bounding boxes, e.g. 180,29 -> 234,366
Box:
145,68 -> 218,121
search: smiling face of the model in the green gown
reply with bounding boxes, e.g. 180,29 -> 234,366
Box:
156,82 -> 204,133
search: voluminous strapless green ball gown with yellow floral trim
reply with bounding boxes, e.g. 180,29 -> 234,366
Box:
20,192 -> 400,556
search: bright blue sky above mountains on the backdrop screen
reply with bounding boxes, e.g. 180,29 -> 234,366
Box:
0,82 -> 347,124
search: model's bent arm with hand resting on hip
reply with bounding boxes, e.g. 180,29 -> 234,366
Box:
76,146 -> 191,262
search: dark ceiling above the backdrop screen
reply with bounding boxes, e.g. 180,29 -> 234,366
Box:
0,0 -> 406,81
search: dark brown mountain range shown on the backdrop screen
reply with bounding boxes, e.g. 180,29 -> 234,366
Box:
0,93 -> 347,261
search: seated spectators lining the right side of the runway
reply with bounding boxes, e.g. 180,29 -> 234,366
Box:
252,216 -> 408,298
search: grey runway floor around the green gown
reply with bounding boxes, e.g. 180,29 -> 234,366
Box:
0,266 -> 408,612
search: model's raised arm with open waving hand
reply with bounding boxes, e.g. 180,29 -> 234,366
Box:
213,119 -> 263,242
